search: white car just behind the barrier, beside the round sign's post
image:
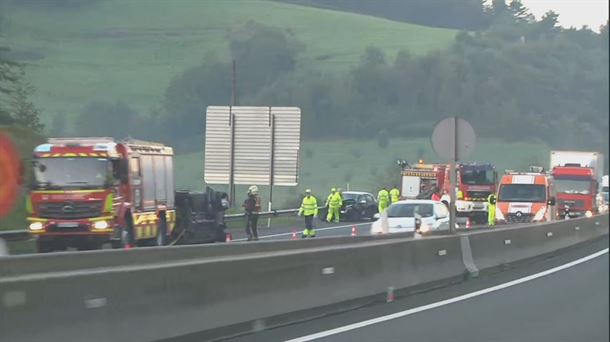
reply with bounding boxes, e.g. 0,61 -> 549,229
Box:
371,200 -> 449,234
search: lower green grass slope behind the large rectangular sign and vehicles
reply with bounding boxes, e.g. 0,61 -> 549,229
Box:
175,139 -> 550,207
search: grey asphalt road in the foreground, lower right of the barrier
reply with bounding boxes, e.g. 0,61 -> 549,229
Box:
226,238 -> 609,342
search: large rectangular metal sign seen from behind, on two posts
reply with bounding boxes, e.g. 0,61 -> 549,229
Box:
204,106 -> 301,186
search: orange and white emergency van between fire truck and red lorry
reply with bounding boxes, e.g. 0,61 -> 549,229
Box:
496,168 -> 555,223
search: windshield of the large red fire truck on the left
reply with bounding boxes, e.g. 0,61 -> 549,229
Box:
34,158 -> 112,188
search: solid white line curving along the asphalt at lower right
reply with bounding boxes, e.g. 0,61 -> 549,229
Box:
285,248 -> 608,342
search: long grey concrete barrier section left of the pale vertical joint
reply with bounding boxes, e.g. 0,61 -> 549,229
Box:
0,237 -> 464,342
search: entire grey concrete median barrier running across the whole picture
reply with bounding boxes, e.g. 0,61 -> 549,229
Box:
0,216 -> 608,342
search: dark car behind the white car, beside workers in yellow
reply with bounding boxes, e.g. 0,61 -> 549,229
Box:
318,191 -> 378,221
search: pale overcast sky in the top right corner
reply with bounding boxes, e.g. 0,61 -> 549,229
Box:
521,0 -> 608,31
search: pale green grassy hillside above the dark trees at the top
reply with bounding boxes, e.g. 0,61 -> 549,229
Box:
3,0 -> 455,122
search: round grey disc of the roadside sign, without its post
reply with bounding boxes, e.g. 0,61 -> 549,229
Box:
432,117 -> 476,161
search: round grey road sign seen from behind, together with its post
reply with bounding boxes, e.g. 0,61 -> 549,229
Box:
431,116 -> 476,233
